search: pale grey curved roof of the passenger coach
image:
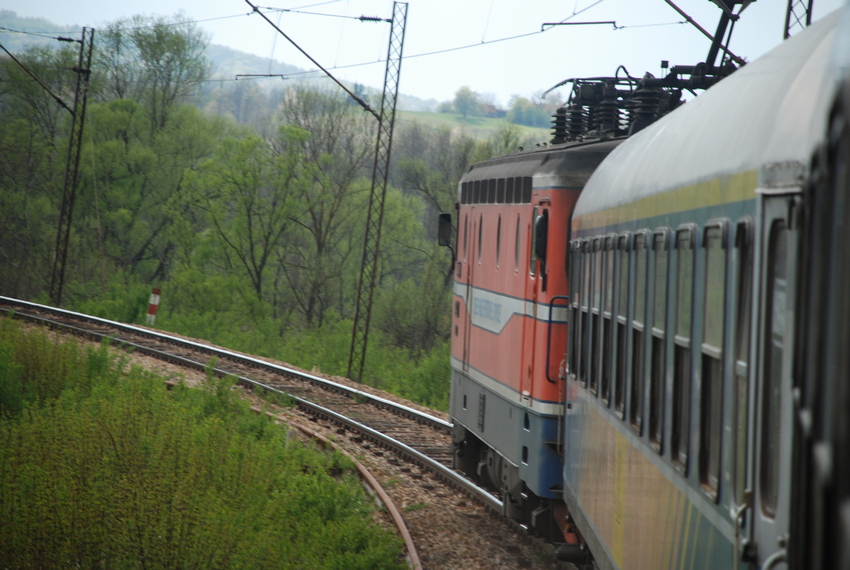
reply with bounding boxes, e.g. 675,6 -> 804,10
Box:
574,12 -> 838,217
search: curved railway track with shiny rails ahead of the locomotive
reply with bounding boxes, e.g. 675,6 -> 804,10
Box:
0,296 -> 502,513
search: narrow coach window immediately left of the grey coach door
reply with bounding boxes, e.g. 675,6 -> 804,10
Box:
732,216 -> 753,505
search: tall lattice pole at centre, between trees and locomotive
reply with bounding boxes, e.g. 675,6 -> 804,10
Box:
348,2 -> 407,381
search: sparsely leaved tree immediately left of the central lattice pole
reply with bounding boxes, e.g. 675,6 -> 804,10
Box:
279,87 -> 376,326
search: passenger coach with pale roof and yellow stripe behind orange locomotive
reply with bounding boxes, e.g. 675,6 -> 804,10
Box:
564,10 -> 837,569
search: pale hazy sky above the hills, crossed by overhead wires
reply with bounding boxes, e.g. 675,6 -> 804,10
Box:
0,0 -> 843,106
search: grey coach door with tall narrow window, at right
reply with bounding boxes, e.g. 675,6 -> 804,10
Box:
751,195 -> 799,570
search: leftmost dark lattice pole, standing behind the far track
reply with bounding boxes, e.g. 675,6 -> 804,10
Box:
50,28 -> 94,307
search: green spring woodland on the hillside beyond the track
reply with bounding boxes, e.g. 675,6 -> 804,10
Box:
0,11 -> 527,409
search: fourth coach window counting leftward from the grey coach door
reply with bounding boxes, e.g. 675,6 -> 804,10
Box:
649,229 -> 670,453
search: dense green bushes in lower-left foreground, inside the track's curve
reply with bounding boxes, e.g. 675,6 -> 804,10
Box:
0,319 -> 403,569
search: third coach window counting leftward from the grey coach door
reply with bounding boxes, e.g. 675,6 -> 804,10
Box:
670,227 -> 694,473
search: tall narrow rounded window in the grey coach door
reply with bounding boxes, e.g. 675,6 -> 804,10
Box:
759,221 -> 788,517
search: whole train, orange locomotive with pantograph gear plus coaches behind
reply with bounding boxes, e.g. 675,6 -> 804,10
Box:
440,8 -> 850,570
